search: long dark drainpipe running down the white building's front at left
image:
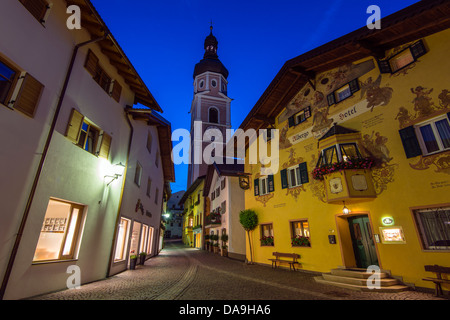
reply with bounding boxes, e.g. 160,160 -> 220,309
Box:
0,31 -> 109,300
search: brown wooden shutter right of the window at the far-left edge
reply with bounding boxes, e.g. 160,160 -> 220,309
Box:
14,73 -> 44,117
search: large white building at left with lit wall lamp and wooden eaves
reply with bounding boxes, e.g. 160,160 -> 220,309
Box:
0,0 -> 171,299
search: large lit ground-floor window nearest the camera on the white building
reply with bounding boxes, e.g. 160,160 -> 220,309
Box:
33,199 -> 84,262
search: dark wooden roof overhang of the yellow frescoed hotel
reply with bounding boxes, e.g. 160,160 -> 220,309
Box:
239,0 -> 450,130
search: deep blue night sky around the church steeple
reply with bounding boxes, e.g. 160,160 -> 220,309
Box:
91,0 -> 418,192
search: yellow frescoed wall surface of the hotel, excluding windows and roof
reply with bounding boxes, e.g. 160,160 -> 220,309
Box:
245,26 -> 450,292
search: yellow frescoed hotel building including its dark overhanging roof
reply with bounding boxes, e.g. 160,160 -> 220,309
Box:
240,1 -> 450,290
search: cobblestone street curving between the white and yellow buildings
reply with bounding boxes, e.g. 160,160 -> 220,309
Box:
29,242 -> 443,301
